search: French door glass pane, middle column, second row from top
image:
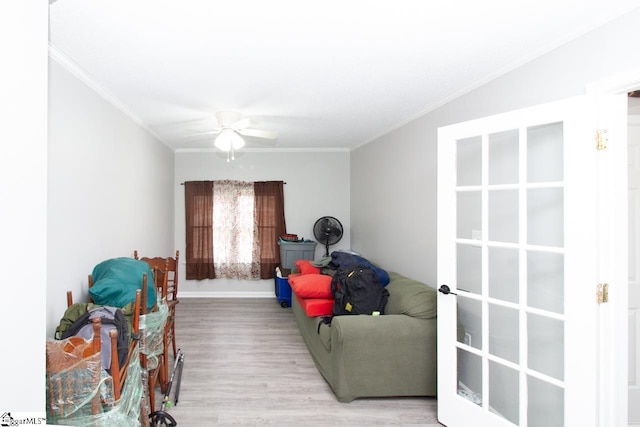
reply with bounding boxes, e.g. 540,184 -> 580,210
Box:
489,190 -> 518,243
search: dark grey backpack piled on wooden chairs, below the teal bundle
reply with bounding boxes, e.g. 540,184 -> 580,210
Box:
62,306 -> 129,371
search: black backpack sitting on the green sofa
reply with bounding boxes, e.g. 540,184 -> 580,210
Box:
331,265 -> 389,316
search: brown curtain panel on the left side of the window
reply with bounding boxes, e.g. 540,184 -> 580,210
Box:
184,181 -> 216,280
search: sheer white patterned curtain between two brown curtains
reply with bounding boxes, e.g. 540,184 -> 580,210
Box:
213,180 -> 260,280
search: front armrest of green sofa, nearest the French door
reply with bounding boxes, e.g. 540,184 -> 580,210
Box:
331,314 -> 437,402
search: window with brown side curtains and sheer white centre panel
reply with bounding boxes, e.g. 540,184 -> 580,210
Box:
185,180 -> 286,280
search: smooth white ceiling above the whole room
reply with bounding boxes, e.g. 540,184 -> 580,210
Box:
50,0 -> 640,149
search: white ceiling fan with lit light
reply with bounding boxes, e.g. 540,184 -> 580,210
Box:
184,111 -> 278,161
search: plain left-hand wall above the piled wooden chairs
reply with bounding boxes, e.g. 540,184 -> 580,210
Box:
46,60 -> 175,336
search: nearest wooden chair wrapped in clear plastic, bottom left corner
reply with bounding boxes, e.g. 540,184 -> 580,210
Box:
46,290 -> 141,423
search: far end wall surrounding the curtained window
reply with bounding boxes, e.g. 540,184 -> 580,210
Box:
175,151 -> 351,297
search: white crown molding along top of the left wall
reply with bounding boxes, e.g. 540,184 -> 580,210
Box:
49,42 -> 174,151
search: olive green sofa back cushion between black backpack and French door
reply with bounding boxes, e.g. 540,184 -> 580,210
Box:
384,273 -> 438,319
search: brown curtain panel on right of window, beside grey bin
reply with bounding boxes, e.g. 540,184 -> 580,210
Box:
254,181 -> 287,279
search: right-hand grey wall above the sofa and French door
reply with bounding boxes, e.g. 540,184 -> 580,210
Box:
351,5 -> 640,287
